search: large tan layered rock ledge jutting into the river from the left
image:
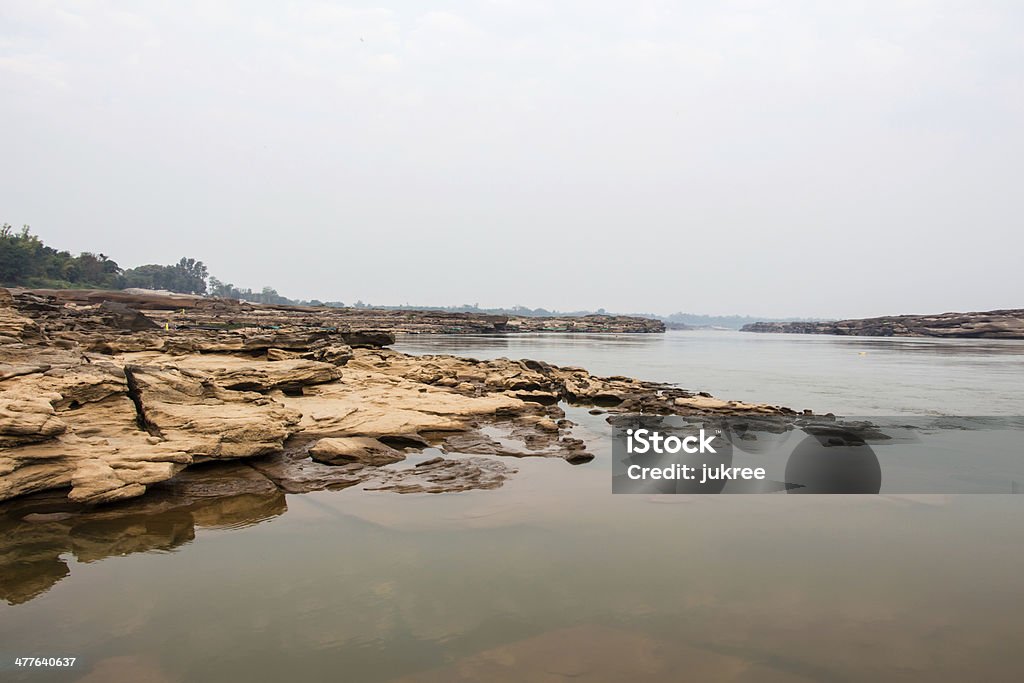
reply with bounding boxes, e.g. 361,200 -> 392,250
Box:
0,290 -> 793,509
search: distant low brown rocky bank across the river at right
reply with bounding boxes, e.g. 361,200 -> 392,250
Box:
742,308 -> 1024,339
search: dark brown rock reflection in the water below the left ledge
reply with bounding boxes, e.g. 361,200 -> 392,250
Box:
0,463 -> 287,604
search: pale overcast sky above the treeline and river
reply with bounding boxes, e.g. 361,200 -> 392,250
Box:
0,0 -> 1024,317
